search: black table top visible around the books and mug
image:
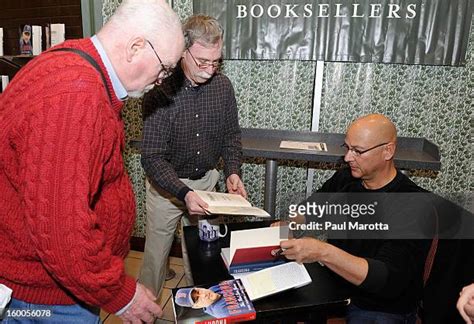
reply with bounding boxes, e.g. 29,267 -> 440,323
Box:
184,222 -> 353,317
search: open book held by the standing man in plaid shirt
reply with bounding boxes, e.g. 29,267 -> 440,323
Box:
194,190 -> 270,217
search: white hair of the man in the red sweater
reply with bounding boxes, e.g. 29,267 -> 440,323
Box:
107,0 -> 181,44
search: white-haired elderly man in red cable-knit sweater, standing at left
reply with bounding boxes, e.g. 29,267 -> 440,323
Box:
0,0 -> 184,323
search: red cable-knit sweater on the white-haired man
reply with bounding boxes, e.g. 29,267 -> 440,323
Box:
0,39 -> 136,313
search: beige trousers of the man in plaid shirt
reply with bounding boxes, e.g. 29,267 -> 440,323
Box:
139,169 -> 219,296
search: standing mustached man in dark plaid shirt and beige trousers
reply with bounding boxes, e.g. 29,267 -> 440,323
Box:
140,15 -> 247,294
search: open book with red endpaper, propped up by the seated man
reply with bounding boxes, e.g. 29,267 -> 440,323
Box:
221,226 -> 289,277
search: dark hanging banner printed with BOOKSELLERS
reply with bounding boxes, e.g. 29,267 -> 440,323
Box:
193,0 -> 474,65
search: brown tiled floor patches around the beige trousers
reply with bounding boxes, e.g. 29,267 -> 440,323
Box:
100,251 -> 187,324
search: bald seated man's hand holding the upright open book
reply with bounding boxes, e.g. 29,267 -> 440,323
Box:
280,237 -> 328,263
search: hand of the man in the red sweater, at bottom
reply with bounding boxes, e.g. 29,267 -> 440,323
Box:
119,283 -> 163,324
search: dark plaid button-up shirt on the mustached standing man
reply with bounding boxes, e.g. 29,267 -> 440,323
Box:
141,64 -> 242,200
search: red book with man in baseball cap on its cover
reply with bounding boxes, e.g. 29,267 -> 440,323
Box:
172,279 -> 256,324
